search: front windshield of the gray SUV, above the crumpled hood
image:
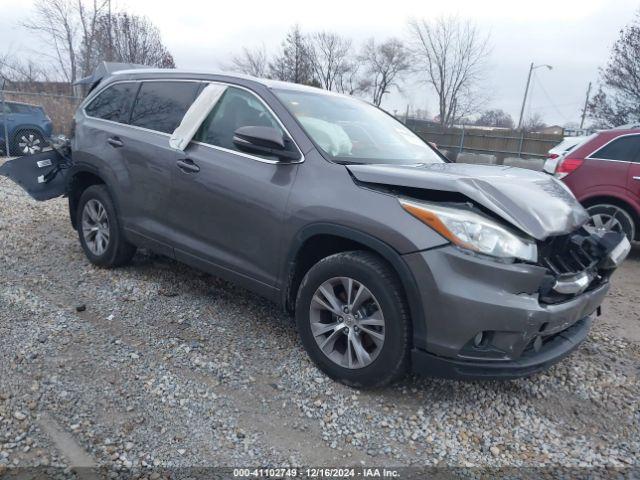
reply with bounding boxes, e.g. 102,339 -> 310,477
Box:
275,90 -> 444,164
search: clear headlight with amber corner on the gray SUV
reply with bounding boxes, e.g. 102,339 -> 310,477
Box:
399,198 -> 538,262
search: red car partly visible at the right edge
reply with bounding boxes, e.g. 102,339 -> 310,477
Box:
545,128 -> 640,240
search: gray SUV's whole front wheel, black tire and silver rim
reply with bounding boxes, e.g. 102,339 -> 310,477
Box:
295,251 -> 411,388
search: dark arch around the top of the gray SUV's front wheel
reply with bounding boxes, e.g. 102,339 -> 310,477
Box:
281,223 -> 426,346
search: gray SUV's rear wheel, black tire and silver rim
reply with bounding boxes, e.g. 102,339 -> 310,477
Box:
76,185 -> 136,268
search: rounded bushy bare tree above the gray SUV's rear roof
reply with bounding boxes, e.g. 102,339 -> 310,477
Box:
94,13 -> 175,68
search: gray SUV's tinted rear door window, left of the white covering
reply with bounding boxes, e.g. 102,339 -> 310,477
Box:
131,81 -> 201,133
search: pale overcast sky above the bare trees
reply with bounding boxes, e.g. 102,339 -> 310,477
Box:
0,0 -> 640,124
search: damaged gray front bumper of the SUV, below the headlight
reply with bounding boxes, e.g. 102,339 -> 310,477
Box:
404,229 -> 630,378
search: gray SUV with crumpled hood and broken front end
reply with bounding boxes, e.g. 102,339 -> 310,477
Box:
2,69 -> 630,387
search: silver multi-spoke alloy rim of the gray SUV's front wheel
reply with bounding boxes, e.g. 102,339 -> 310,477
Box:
309,277 -> 385,369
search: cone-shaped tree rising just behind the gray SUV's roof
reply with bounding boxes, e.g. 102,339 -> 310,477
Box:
269,25 -> 317,85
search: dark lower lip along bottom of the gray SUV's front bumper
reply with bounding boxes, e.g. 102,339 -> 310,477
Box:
411,317 -> 592,380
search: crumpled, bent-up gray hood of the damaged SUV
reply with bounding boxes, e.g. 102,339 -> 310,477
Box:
347,163 -> 588,240
